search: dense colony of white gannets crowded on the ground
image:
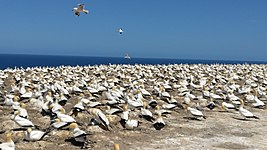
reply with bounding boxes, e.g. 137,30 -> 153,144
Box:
0,64 -> 267,150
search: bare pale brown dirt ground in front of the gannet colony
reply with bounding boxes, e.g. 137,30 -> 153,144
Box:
0,102 -> 267,150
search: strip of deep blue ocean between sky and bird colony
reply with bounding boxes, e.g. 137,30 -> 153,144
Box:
0,54 -> 267,70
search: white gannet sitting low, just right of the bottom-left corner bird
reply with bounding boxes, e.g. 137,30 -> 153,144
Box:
25,128 -> 49,141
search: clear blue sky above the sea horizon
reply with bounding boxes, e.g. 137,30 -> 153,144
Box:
0,0 -> 267,61
